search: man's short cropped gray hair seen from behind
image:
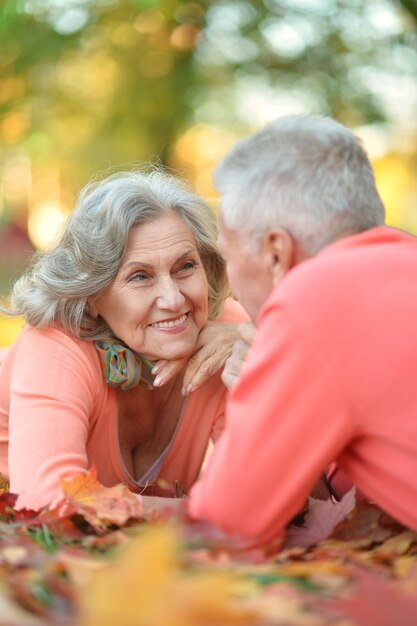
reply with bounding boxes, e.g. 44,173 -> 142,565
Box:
214,115 -> 385,255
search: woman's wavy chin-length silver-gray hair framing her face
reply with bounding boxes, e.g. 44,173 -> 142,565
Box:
4,170 -> 227,339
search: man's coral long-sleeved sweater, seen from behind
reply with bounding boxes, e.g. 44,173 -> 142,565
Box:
189,227 -> 417,541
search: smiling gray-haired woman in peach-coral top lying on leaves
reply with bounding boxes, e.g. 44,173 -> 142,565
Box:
0,171 -> 247,509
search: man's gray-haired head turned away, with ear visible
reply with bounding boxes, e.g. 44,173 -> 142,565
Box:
214,115 -> 384,320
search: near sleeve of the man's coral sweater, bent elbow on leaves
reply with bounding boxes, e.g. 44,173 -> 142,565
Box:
189,305 -> 353,541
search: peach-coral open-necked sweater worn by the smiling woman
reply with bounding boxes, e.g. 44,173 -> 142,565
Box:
0,300 -> 248,509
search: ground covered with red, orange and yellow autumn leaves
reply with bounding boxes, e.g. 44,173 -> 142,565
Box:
0,472 -> 417,626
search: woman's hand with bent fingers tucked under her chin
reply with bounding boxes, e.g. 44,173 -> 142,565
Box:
152,322 -> 254,395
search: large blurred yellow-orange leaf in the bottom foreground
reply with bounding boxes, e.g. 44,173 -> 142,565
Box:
80,526 -> 256,626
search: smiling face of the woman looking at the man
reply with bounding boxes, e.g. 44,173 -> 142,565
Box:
90,213 -> 208,361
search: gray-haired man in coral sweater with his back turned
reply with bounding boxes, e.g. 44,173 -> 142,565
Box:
189,116 -> 417,541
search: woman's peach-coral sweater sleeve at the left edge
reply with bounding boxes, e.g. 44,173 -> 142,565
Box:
9,329 -> 99,509
